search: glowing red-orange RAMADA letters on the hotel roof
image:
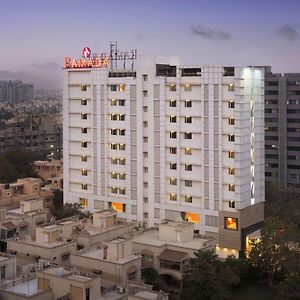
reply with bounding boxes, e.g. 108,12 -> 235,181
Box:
64,57 -> 110,69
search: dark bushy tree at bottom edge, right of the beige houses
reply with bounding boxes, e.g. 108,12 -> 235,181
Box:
181,250 -> 240,300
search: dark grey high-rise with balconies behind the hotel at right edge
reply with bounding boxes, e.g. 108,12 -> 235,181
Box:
265,67 -> 300,188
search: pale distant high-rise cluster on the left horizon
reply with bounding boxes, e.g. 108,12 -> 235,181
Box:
0,80 -> 33,103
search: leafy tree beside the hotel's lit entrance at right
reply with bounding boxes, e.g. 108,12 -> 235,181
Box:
249,217 -> 286,287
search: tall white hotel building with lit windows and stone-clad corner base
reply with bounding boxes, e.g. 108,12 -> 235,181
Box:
63,56 -> 265,253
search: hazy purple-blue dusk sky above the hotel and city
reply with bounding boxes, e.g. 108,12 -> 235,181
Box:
0,0 -> 300,88
